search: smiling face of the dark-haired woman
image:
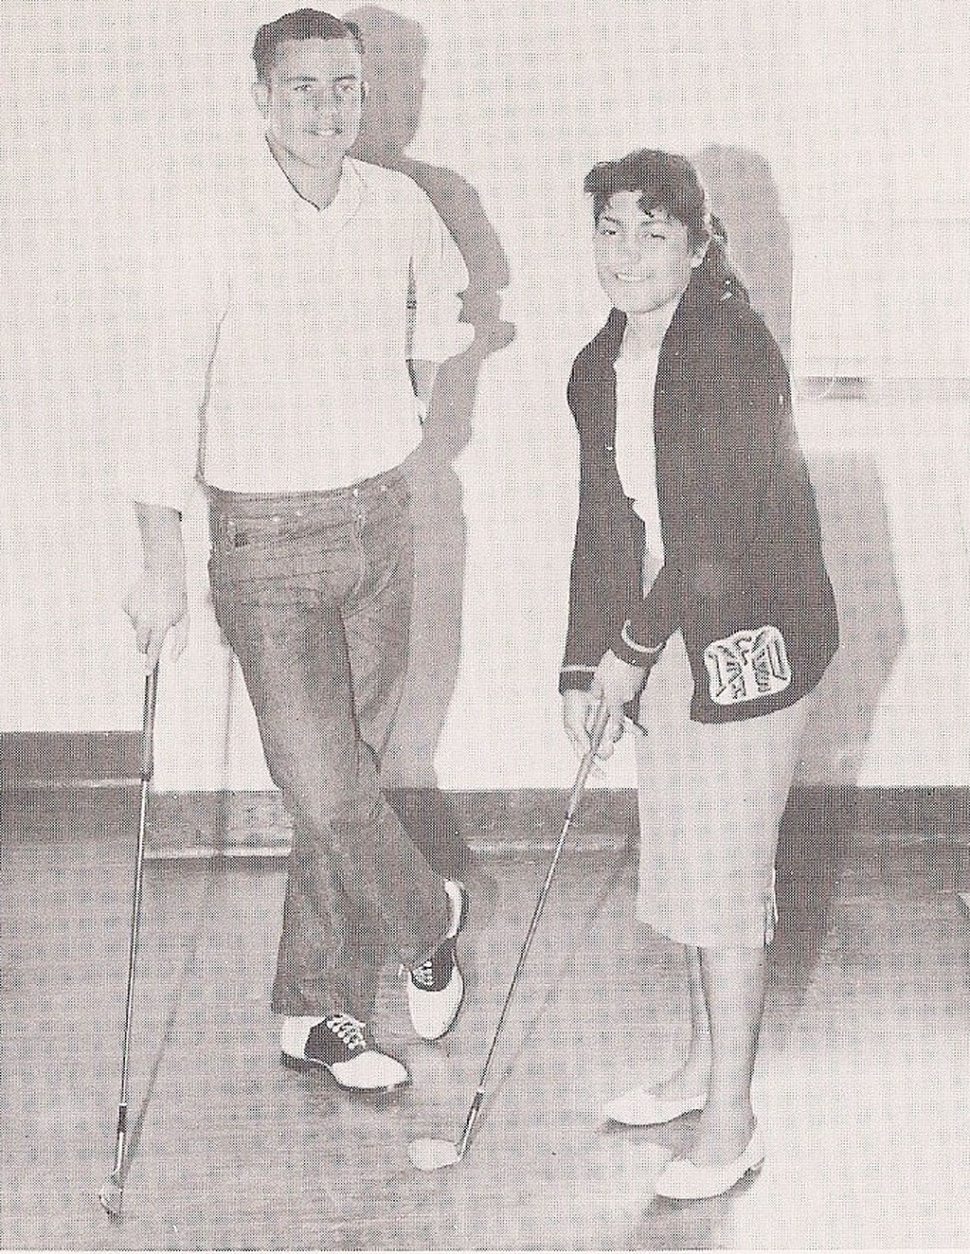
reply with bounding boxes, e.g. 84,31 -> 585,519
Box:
595,192 -> 704,314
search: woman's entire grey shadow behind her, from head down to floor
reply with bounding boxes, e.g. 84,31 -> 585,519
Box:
692,144 -> 905,1018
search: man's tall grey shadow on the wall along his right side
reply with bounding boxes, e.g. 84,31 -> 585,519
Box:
343,5 -> 515,878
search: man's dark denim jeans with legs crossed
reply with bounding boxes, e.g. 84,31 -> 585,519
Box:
209,472 -> 449,1020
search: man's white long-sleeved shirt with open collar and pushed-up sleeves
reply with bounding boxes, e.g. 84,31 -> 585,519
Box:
132,145 -> 474,509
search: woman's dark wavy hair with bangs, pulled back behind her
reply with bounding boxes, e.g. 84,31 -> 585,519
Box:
583,148 -> 748,303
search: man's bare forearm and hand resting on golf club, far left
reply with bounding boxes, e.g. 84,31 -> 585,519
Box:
124,503 -> 188,673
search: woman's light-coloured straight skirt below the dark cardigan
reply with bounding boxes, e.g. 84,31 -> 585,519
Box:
637,632 -> 806,948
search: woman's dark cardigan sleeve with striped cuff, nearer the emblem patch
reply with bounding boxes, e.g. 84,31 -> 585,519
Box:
610,308 -> 791,666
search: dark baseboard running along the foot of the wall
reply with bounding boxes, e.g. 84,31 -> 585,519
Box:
0,731 -> 970,858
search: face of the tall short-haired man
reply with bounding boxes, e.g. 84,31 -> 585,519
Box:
253,39 -> 363,168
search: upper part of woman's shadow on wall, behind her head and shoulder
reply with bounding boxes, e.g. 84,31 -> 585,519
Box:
691,144 -> 792,361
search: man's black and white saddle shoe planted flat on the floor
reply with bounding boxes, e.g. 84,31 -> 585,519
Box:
279,1014 -> 409,1092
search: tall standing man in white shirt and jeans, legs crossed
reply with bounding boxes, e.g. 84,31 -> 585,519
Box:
129,9 -> 474,1091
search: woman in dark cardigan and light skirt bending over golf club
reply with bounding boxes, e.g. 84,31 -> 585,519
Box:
560,150 -> 838,1198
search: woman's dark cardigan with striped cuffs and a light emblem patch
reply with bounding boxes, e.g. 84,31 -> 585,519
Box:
559,272 -> 838,722
